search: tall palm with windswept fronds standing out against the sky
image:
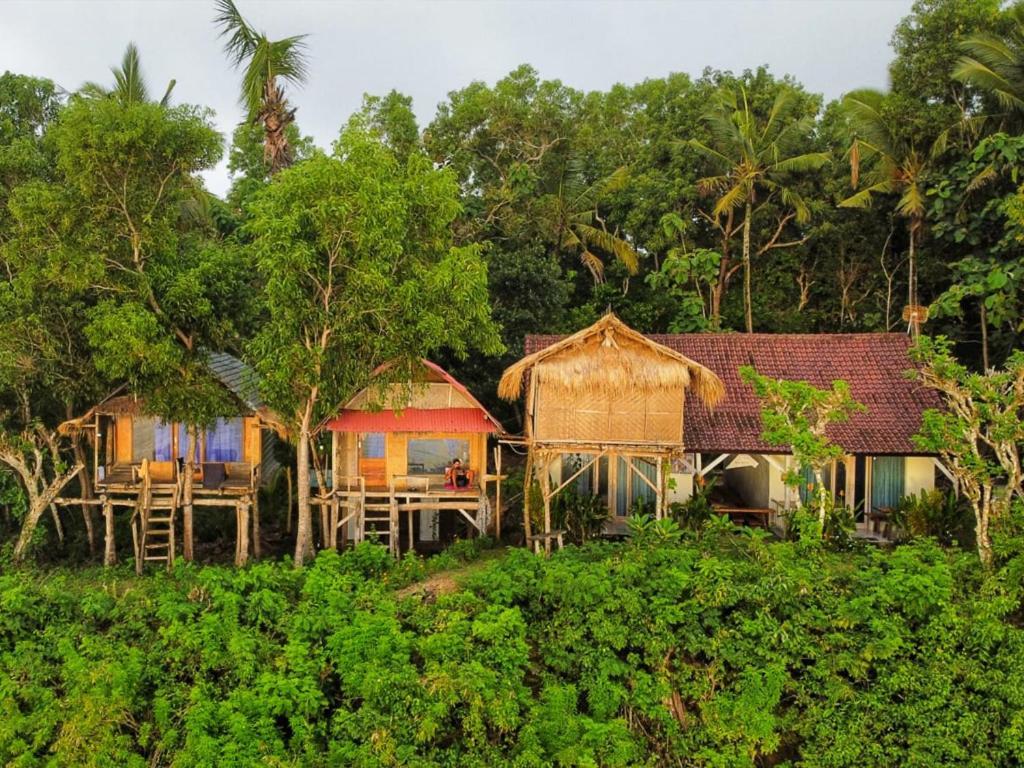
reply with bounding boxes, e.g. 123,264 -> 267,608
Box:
216,0 -> 307,174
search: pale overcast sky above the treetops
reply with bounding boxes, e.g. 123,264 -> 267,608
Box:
0,0 -> 911,194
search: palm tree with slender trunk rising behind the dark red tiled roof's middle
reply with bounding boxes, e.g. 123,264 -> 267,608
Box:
687,86 -> 829,333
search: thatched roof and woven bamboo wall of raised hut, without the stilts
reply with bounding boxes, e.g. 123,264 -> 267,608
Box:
498,312 -> 725,447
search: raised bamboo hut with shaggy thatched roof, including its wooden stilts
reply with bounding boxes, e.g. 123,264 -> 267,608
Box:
498,312 -> 725,551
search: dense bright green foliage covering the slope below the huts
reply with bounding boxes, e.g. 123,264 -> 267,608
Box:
0,536 -> 1024,766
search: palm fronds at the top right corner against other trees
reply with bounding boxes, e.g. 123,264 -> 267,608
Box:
953,3 -> 1024,132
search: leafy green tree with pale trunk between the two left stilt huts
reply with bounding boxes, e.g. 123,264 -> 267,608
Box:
247,122 -> 501,566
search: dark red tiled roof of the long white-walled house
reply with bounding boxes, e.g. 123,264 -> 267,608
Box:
525,333 -> 941,456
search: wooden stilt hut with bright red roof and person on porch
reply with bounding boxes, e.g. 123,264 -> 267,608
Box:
321,359 -> 504,554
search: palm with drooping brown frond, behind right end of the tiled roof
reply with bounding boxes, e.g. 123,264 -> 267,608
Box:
840,88 -> 932,336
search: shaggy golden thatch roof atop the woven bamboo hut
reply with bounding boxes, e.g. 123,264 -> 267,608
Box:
498,312 -> 725,408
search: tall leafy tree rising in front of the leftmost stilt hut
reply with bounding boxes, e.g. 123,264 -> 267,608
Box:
10,98 -> 245,556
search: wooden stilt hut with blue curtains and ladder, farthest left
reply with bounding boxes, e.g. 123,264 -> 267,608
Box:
58,353 -> 283,570
